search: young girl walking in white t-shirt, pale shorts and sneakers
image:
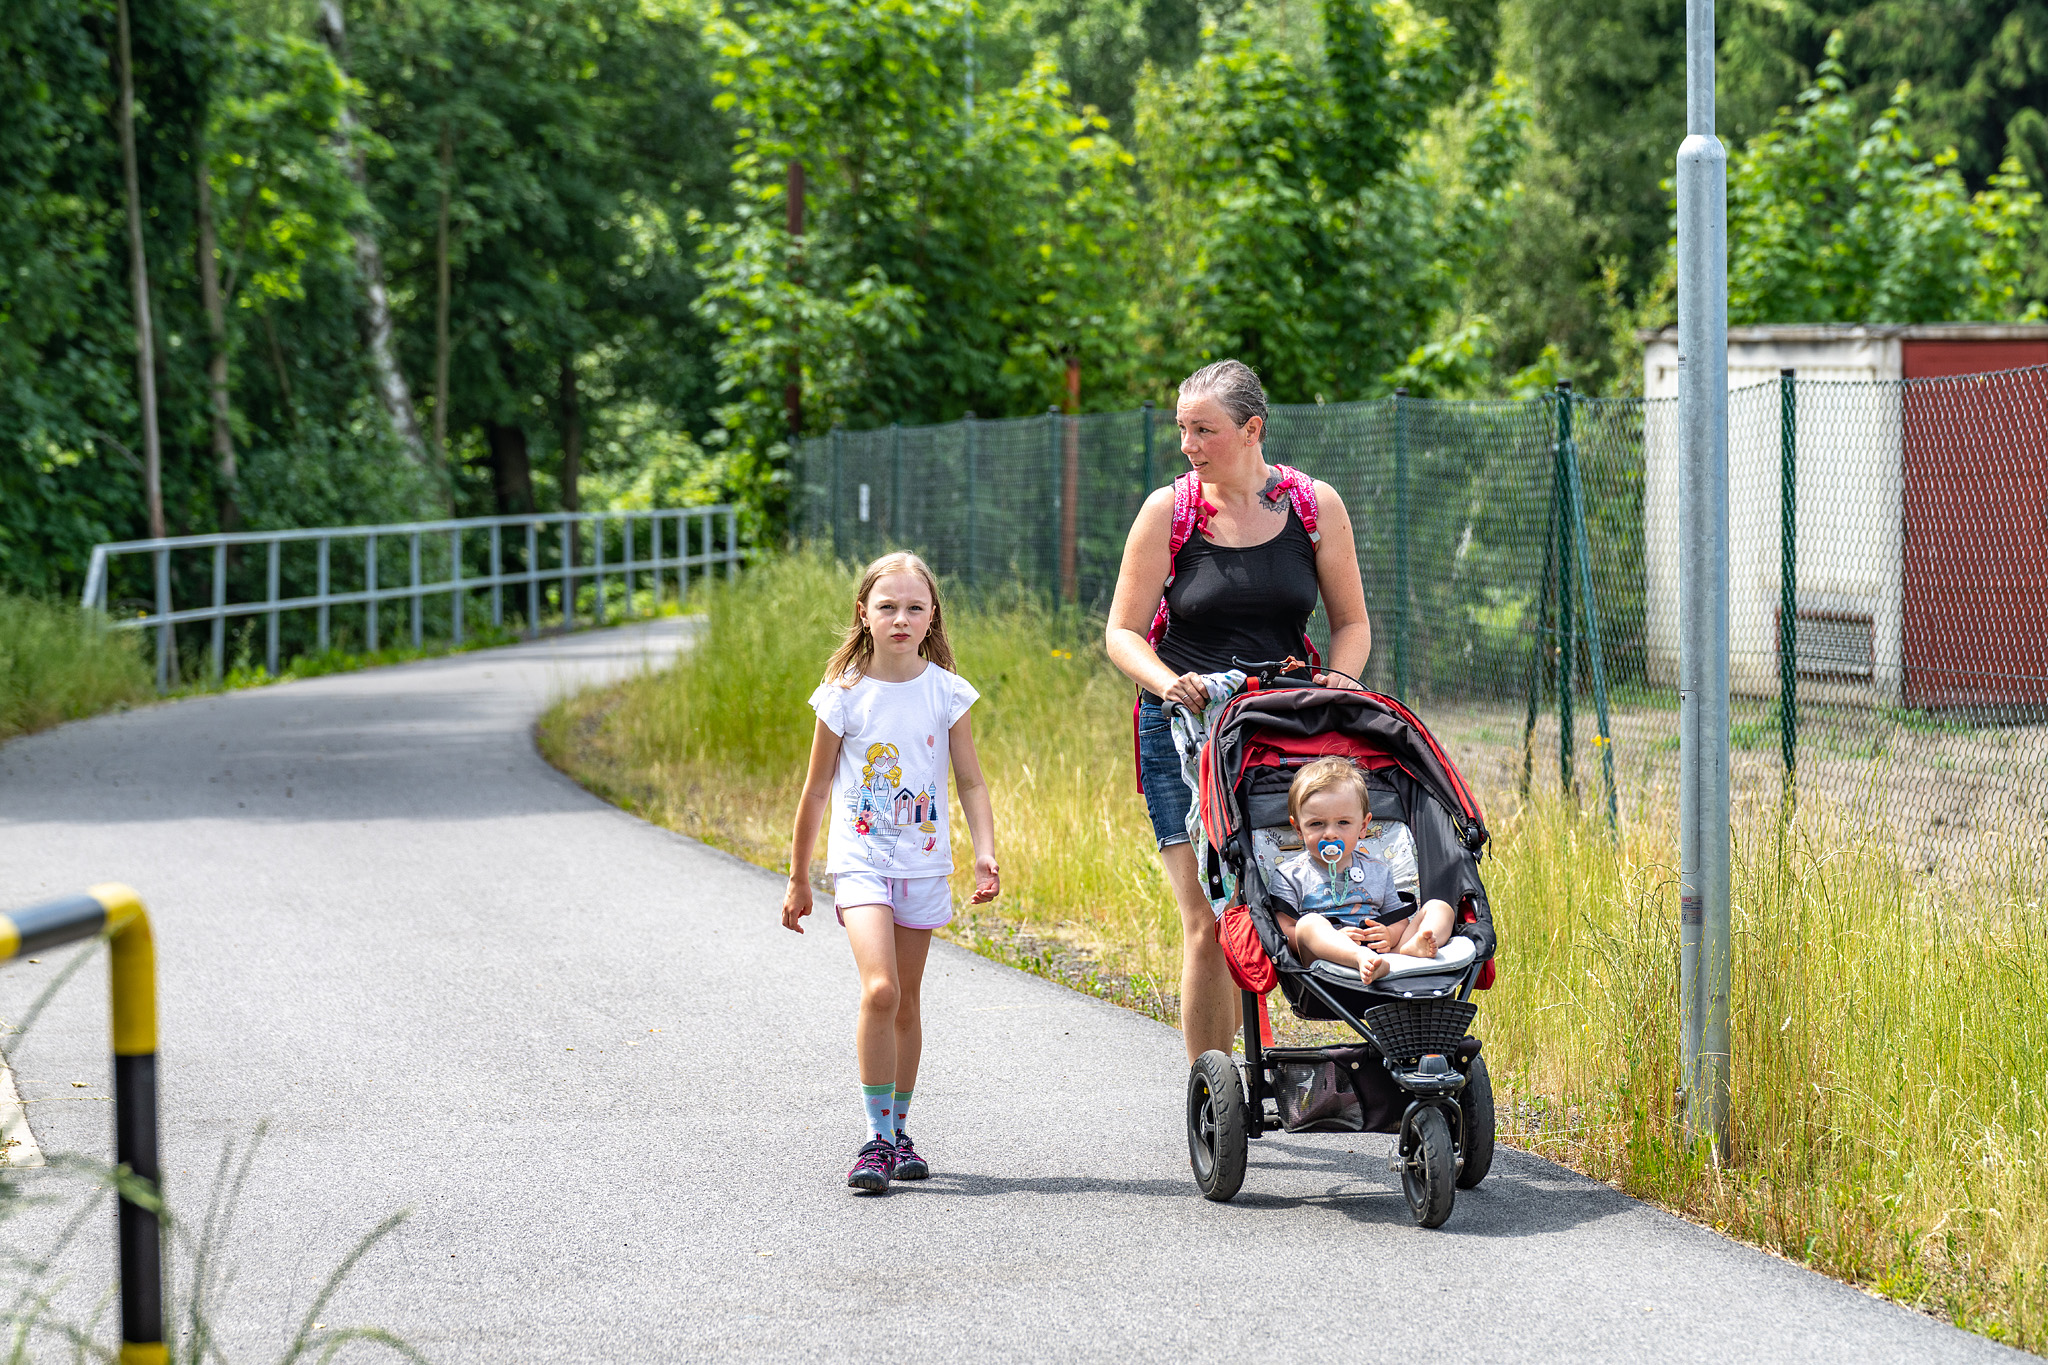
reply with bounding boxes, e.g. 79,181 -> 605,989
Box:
782,553 -> 999,1193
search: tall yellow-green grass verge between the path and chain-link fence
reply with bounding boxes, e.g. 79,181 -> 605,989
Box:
541,557 -> 2048,1351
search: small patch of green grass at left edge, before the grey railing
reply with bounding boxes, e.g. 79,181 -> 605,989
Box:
0,591 -> 150,739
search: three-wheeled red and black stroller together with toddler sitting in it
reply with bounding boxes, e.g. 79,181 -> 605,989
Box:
1186,661 -> 1495,1228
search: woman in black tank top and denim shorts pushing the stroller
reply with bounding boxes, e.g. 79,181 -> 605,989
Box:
1104,360 -> 1372,1062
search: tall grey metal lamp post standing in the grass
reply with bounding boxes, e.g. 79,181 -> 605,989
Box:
1677,0 -> 1731,1156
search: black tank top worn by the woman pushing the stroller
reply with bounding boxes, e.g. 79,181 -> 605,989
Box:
1159,503 -> 1317,687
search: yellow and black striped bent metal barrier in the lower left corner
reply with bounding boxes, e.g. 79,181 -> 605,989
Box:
0,882 -> 170,1365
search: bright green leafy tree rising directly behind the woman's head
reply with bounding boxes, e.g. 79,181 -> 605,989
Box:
1139,0 -> 1526,401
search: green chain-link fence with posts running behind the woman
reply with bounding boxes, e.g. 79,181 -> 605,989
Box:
799,370 -> 2048,868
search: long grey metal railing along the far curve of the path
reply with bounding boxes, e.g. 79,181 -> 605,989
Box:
82,503 -> 743,690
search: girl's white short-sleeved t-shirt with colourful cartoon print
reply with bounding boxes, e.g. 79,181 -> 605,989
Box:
811,661 -> 981,878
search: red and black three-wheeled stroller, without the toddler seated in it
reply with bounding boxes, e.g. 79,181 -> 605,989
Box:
1188,659 -> 1495,1228
